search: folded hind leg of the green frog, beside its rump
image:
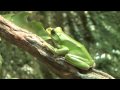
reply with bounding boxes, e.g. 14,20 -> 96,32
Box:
65,53 -> 90,70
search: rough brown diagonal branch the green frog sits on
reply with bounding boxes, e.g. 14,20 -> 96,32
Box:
0,15 -> 114,79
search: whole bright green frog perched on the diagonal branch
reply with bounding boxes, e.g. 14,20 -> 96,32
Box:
46,27 -> 95,70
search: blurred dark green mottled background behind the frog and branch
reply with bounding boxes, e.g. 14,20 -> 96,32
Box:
0,11 -> 120,79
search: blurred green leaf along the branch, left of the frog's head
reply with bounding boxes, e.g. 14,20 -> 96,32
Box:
3,12 -> 50,40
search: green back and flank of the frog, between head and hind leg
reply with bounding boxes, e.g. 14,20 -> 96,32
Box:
60,34 -> 92,60
